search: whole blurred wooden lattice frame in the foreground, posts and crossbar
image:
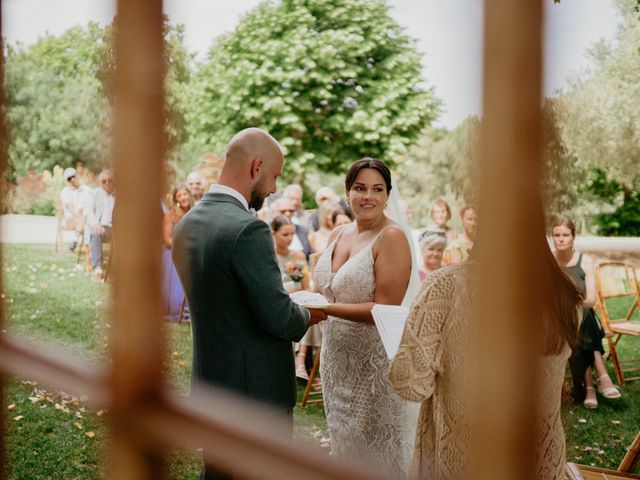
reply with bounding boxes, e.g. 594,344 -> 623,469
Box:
0,0 -> 542,480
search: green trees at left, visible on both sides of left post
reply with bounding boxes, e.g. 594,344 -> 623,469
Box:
4,20 -> 192,176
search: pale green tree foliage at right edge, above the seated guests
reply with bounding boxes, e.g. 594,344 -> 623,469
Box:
555,0 -> 640,235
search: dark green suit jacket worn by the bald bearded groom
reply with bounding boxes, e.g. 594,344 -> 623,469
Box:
172,193 -> 309,411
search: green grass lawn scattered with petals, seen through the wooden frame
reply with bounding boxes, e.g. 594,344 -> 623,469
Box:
3,245 -> 640,480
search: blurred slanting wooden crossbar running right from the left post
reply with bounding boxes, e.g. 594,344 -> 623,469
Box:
125,390 -> 385,480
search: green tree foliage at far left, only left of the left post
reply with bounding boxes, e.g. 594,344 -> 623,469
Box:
4,23 -> 107,175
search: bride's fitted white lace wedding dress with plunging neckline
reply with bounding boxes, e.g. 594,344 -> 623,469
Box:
315,231 -> 419,478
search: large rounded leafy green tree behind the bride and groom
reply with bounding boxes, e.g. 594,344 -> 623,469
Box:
190,0 -> 439,174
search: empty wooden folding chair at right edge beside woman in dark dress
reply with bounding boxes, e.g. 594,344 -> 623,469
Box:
595,262 -> 640,385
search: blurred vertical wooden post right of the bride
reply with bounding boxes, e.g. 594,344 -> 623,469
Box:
472,0 -> 544,480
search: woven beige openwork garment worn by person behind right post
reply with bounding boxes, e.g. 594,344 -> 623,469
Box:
389,264 -> 571,480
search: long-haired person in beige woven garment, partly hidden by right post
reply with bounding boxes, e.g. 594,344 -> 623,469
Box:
389,235 -> 581,480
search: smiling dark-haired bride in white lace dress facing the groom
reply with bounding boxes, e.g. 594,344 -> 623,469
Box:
315,159 -> 418,478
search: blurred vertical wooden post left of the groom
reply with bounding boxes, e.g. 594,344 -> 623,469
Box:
109,0 -> 165,480
